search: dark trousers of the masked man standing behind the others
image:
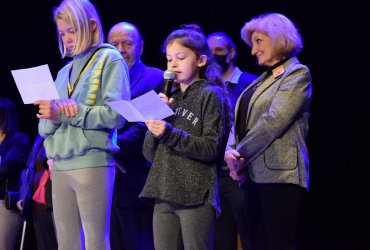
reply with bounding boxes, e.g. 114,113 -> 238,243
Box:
213,170 -> 248,250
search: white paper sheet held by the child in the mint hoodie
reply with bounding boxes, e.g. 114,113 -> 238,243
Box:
11,64 -> 59,104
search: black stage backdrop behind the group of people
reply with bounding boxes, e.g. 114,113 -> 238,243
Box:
0,0 -> 362,250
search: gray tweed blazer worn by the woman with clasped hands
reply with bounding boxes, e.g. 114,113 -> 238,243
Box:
227,57 -> 311,188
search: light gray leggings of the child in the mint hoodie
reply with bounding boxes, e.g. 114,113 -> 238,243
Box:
52,167 -> 114,250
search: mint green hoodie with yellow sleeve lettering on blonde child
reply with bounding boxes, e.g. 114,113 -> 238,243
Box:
39,44 -> 130,170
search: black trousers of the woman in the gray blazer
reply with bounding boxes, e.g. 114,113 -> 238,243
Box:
242,181 -> 306,250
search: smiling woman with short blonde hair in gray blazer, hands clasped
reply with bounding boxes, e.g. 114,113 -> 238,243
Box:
225,13 -> 311,250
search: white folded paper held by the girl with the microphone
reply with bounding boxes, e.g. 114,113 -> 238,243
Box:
107,90 -> 173,122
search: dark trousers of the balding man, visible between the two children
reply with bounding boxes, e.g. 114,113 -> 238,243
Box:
110,196 -> 154,250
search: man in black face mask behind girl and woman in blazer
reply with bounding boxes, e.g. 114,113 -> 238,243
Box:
207,32 -> 257,250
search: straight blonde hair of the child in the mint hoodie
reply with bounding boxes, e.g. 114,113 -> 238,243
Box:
54,0 -> 104,58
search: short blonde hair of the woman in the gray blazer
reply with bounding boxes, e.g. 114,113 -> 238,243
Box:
240,13 -> 303,57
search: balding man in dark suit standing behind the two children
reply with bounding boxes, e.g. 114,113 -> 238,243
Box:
108,22 -> 163,250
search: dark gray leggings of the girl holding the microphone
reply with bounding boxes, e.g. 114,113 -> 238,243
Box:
153,200 -> 216,250
